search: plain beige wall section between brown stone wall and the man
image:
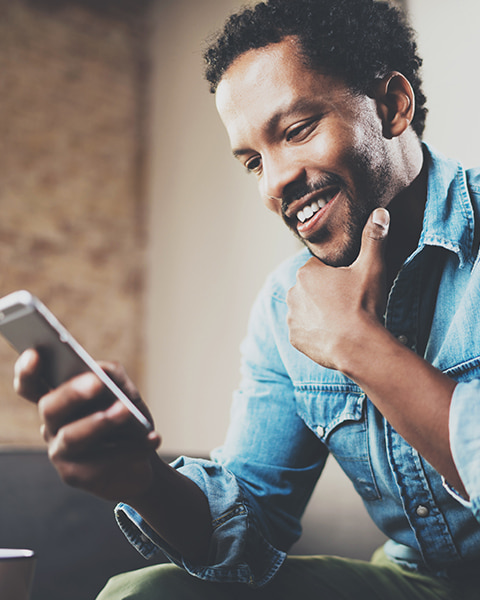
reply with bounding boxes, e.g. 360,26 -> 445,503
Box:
144,0 -> 297,453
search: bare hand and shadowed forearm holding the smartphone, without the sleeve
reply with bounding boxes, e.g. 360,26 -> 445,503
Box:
15,350 -> 211,564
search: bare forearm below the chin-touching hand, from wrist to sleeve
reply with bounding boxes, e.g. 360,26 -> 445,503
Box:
340,324 -> 465,493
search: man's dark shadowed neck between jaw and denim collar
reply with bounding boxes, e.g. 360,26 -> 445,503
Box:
386,143 -> 428,289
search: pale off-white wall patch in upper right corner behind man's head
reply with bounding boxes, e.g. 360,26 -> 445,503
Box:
408,0 -> 480,167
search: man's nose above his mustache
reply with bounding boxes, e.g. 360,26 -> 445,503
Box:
260,155 -> 305,212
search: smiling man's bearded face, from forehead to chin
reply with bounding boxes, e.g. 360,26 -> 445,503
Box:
216,38 -> 396,266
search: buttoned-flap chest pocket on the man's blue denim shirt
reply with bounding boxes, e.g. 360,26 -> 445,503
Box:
295,386 -> 381,501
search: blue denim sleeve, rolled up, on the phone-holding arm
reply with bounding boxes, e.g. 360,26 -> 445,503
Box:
112,253 -> 328,587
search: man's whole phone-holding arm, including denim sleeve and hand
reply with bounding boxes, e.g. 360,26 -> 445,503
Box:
16,267 -> 327,587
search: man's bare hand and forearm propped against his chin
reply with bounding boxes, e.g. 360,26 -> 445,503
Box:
288,209 -> 465,493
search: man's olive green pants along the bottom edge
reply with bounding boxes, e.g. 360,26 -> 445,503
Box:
97,550 -> 474,600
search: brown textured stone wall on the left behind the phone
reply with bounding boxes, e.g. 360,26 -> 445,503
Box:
0,0 -> 148,445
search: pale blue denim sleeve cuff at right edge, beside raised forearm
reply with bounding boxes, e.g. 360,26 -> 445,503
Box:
447,379 -> 480,521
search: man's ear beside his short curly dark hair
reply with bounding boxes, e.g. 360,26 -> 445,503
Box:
375,71 -> 415,139
